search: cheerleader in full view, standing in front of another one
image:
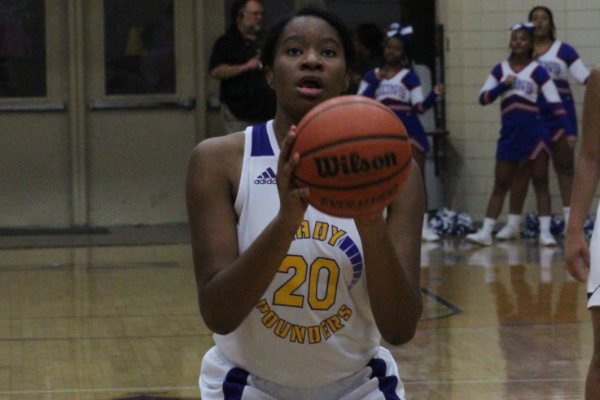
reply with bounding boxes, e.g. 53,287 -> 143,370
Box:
467,23 -> 571,246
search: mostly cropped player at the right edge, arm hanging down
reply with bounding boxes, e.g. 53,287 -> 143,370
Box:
565,64 -> 600,400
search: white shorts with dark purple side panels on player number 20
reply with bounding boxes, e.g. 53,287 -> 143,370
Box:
200,346 -> 405,400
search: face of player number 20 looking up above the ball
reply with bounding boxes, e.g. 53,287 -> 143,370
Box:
265,16 -> 350,120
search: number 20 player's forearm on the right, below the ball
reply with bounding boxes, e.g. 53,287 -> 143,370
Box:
355,161 -> 425,345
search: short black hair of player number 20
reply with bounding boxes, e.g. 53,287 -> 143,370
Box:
260,6 -> 355,69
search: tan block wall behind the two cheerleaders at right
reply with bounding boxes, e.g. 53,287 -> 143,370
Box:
438,0 -> 600,220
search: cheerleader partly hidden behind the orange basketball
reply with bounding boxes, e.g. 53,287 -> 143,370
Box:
358,23 -> 444,241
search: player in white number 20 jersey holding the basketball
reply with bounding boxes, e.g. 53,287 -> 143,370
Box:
186,8 -> 424,400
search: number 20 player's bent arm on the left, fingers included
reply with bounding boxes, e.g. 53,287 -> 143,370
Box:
186,128 -> 306,334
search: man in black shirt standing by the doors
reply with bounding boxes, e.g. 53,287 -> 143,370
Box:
209,0 -> 276,133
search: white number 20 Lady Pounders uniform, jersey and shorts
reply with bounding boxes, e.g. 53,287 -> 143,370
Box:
200,121 -> 404,400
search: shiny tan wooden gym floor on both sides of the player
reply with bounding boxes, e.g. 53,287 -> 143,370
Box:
0,226 -> 592,400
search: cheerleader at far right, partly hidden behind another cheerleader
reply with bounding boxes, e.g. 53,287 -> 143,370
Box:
496,6 -> 589,240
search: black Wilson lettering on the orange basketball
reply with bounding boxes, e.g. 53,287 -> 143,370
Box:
314,152 -> 398,178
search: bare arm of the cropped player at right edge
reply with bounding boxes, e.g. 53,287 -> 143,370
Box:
565,64 -> 600,282
